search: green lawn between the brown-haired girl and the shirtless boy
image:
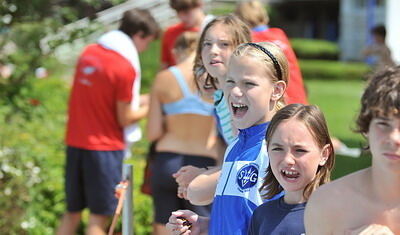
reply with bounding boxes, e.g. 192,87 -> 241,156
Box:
306,80 -> 371,179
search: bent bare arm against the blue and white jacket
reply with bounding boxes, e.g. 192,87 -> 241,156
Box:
187,166 -> 221,206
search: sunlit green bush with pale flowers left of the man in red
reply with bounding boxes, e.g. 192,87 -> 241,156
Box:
0,76 -> 66,234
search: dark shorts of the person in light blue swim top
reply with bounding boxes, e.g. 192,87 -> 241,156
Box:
150,152 -> 216,224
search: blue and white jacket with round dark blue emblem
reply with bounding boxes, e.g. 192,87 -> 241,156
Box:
208,123 -> 269,235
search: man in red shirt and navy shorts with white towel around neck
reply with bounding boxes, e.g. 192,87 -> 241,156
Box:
57,9 -> 159,234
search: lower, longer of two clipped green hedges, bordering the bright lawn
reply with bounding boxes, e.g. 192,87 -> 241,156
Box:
300,60 -> 370,80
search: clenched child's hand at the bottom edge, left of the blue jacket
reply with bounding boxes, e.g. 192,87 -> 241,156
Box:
166,210 -> 200,235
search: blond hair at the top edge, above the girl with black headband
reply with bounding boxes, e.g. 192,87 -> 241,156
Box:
235,0 -> 269,28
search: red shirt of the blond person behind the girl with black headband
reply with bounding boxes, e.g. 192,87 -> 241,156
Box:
252,28 -> 308,104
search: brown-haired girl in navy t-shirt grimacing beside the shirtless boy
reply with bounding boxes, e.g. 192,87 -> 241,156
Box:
248,104 -> 334,235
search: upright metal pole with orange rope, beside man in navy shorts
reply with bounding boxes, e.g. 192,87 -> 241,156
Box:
122,164 -> 133,235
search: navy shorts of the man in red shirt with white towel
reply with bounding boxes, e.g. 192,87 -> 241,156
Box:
65,146 -> 123,215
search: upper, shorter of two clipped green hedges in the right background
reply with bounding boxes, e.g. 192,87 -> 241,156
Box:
290,38 -> 339,60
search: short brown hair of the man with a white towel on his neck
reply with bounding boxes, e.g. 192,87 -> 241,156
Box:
119,9 -> 160,38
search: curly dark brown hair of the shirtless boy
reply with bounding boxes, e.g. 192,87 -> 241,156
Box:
356,66 -> 400,134
